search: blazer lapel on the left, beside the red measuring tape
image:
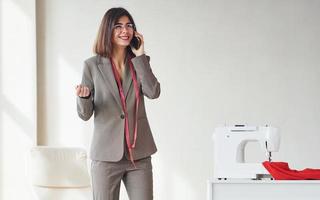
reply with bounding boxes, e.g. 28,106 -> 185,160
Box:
98,56 -> 122,109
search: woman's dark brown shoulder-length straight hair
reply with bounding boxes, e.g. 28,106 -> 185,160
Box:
94,7 -> 137,57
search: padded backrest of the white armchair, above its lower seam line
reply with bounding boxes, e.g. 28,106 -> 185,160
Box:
29,146 -> 90,188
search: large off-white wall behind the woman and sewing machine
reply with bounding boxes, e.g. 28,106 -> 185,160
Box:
37,0 -> 320,200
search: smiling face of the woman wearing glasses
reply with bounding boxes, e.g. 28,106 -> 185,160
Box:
112,16 -> 134,47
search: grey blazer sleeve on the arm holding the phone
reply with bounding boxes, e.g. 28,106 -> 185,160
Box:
131,54 -> 160,99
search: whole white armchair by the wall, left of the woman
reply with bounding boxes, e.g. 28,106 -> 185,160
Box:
29,146 -> 92,200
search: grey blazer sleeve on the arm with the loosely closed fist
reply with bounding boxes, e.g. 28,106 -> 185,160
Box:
77,62 -> 94,121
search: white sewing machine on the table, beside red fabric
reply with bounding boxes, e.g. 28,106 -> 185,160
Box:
213,125 -> 280,179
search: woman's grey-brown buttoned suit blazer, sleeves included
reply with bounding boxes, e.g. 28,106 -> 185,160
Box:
77,55 -> 160,161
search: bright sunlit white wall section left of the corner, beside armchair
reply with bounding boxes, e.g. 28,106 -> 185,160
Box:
0,0 -> 37,200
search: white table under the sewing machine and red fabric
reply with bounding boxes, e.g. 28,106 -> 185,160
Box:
207,179 -> 320,200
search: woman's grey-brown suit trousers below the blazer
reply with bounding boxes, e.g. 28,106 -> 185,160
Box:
91,156 -> 153,200
